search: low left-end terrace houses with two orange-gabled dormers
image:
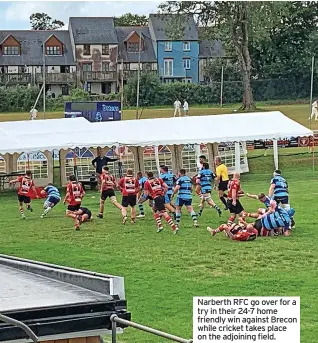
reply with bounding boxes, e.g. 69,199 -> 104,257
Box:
0,30 -> 76,96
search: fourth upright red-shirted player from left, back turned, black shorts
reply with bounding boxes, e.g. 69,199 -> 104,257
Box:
118,169 -> 140,225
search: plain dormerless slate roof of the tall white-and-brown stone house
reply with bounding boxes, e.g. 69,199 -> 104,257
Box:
69,17 -> 118,44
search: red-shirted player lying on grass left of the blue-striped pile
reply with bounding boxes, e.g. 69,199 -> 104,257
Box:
207,218 -> 258,241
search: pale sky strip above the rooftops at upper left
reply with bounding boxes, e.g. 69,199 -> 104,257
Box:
0,0 -> 162,30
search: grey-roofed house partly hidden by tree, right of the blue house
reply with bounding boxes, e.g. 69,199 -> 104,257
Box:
199,28 -> 225,84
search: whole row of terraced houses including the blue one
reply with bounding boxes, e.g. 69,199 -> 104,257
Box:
0,14 -> 222,97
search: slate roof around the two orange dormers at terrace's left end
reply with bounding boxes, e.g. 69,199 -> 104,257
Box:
0,30 -> 75,66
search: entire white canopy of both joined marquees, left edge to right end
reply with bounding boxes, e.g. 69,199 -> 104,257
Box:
0,111 -> 313,154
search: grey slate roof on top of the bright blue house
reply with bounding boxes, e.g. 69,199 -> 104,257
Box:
149,14 -> 198,41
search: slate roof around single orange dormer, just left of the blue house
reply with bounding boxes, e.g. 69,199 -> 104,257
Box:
116,26 -> 157,63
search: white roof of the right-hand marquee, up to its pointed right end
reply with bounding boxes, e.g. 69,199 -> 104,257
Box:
92,111 -> 313,146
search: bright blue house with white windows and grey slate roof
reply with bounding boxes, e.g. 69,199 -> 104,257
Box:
149,14 -> 199,83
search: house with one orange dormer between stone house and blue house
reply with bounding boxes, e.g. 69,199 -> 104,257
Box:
116,26 -> 157,82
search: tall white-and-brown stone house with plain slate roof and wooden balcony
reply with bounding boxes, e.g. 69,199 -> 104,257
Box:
69,17 -> 118,94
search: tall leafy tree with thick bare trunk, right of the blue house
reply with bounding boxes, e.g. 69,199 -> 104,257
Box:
160,1 -> 285,111
